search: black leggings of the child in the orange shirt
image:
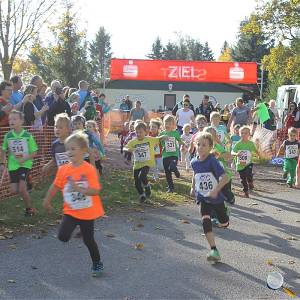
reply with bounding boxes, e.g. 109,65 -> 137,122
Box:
58,215 -> 100,262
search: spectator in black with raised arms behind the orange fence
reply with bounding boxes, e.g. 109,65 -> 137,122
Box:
47,86 -> 72,126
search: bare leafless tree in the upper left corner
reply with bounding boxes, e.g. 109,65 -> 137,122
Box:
0,0 -> 56,80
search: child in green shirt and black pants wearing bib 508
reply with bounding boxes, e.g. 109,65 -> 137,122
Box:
232,126 -> 259,198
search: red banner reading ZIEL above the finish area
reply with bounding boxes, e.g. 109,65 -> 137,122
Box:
110,59 -> 257,84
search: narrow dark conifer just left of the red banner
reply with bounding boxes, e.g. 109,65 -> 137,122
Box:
89,26 -> 112,83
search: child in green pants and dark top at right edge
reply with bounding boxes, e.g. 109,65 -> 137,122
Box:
277,127 -> 300,187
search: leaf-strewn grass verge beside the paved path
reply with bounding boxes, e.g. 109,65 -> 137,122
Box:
0,170 -> 191,239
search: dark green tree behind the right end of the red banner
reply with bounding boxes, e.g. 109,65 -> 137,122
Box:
231,19 -> 274,62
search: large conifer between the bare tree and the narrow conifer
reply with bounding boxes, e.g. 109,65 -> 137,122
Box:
30,2 -> 91,87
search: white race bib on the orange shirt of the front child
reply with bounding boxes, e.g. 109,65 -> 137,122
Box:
64,181 -> 92,210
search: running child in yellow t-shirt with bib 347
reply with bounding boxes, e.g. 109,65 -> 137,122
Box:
126,122 -> 159,203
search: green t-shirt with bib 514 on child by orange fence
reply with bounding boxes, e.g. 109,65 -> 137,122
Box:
2,129 -> 38,171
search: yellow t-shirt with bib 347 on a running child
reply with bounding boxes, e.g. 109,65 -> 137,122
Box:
126,136 -> 159,170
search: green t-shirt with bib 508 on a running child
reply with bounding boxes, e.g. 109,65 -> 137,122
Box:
233,140 -> 257,171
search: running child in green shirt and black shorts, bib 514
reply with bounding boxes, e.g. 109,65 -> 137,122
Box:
0,110 -> 38,216
